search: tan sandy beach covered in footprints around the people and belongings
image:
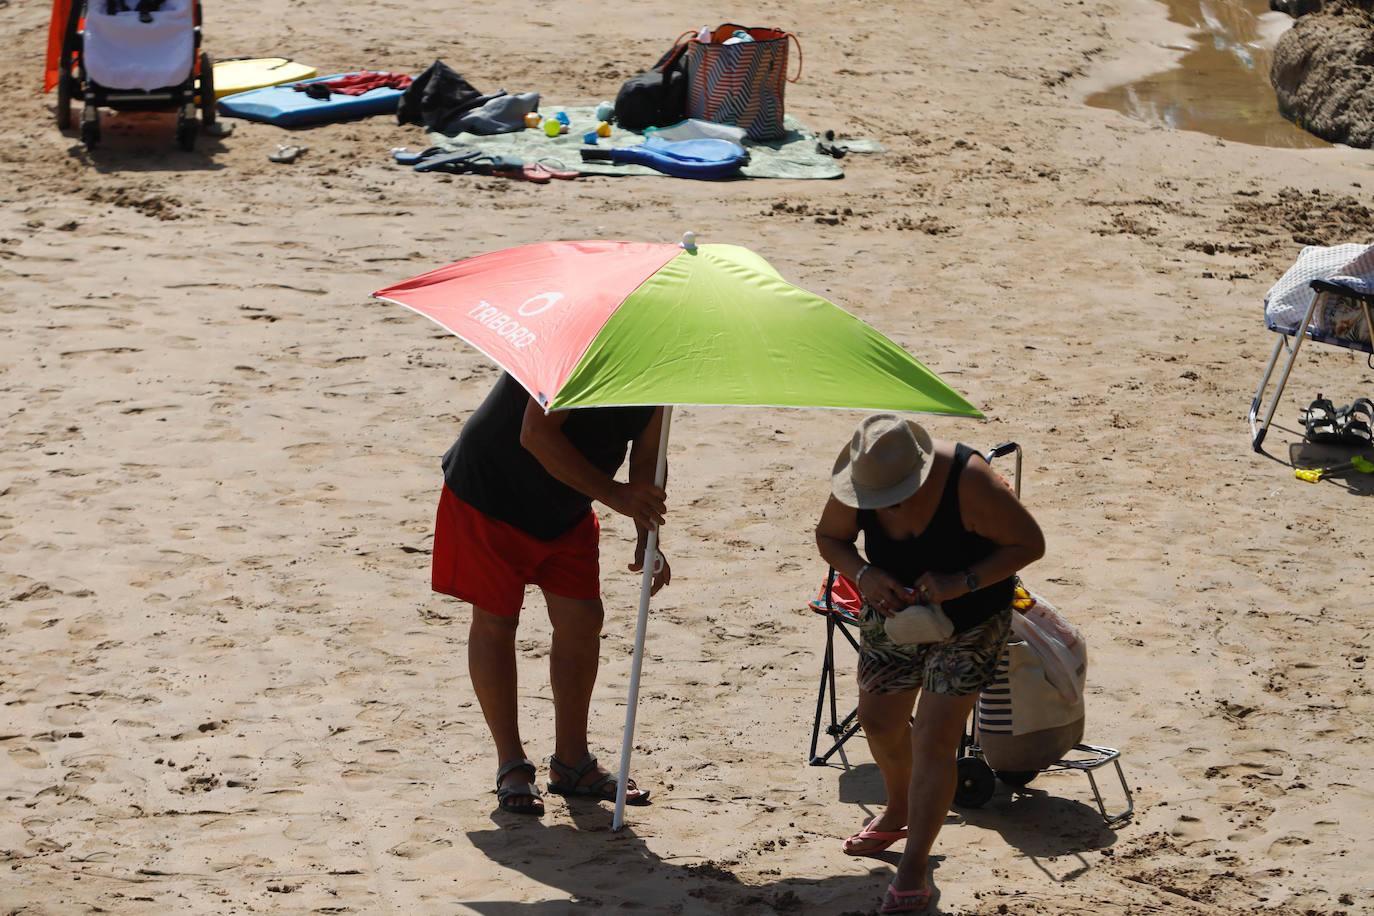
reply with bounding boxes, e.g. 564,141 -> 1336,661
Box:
0,0 -> 1374,916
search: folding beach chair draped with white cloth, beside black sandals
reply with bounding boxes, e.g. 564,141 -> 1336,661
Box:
1249,244 -> 1374,452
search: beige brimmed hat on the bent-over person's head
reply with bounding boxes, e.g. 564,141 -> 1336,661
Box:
830,413 -> 934,509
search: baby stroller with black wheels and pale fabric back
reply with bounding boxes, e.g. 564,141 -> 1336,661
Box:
49,0 -> 214,151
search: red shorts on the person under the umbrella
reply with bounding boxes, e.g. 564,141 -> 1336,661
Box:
433,486 -> 600,617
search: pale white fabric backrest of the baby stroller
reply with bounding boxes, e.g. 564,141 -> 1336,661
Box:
81,0 -> 195,89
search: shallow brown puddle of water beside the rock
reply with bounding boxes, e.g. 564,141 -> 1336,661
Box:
1085,0 -> 1331,147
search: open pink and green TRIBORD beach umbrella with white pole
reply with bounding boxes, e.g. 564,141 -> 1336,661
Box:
372,232 -> 982,829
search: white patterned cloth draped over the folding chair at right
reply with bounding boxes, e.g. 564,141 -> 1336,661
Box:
1264,243 -> 1374,349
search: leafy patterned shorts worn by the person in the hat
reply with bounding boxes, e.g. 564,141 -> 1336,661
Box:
859,602 -> 1011,696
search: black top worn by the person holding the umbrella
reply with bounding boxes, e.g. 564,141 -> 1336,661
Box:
444,372 -> 654,541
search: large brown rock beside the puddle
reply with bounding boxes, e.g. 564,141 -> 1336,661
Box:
1270,0 -> 1374,148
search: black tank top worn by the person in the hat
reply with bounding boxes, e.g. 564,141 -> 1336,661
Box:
859,444 -> 1015,632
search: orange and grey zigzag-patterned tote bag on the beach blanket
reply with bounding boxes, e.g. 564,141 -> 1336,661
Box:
683,23 -> 801,140
